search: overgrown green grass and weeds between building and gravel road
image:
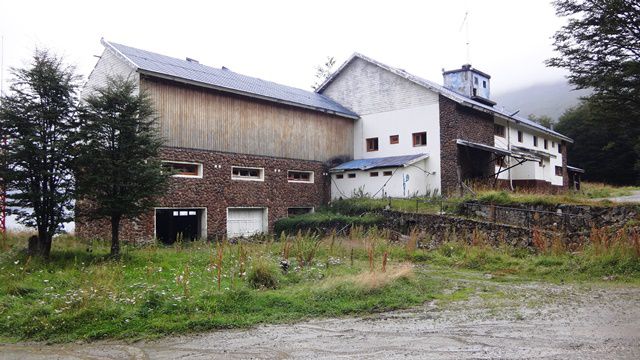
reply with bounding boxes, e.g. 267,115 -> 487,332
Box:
0,227 -> 640,342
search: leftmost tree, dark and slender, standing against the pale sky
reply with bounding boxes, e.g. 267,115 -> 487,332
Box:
0,50 -> 79,258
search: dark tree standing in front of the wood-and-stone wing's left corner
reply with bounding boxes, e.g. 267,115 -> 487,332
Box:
77,78 -> 168,257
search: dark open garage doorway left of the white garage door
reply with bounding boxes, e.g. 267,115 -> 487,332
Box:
156,209 -> 204,245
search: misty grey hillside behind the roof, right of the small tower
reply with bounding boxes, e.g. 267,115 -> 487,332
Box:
493,81 -> 588,120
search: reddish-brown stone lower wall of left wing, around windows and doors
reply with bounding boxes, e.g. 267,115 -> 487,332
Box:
76,148 -> 330,242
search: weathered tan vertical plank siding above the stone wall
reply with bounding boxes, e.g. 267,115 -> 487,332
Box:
140,77 -> 354,161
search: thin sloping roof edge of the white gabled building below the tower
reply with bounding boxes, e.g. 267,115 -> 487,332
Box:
316,53 -> 573,143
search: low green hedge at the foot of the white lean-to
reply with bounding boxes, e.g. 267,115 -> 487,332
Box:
273,212 -> 382,234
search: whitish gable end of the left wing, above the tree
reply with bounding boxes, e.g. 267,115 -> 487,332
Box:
81,49 -> 140,98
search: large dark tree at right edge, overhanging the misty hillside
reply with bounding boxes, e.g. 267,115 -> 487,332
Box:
547,0 -> 640,183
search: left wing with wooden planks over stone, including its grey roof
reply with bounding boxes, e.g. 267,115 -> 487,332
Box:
76,40 -> 358,243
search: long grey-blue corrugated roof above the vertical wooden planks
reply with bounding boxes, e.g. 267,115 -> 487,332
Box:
102,40 -> 358,118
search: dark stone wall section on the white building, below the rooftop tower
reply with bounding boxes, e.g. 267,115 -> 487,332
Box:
439,95 -> 494,194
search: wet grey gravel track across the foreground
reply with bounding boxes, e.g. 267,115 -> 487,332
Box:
0,280 -> 640,359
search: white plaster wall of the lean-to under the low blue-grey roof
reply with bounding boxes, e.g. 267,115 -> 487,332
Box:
331,159 -> 439,199
